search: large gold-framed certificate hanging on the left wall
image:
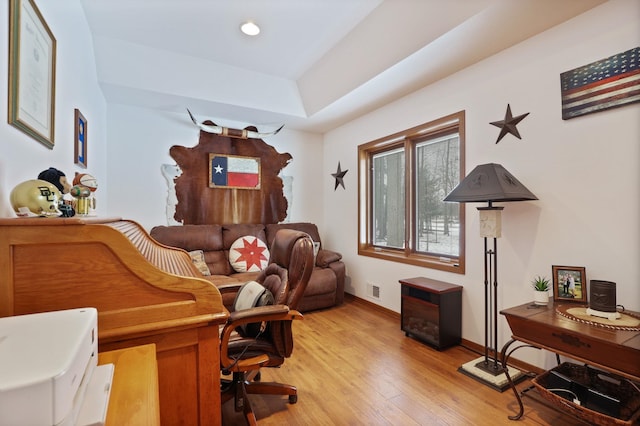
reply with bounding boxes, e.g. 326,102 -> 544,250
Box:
8,0 -> 56,149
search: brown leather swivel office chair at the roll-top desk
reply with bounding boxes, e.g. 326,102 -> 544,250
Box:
220,229 -> 314,425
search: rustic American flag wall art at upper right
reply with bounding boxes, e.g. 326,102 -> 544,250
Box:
560,47 -> 640,120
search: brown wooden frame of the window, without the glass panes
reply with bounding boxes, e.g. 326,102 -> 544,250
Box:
358,111 -> 466,274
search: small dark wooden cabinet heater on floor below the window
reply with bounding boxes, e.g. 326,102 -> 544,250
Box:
400,277 -> 462,350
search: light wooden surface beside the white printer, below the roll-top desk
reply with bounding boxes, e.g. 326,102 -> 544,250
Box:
98,344 -> 160,426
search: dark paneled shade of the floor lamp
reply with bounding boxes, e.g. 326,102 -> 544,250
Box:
444,163 -> 538,203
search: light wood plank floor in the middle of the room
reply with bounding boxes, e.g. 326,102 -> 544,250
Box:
223,298 -> 582,426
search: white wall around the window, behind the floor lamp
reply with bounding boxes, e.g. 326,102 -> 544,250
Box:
324,0 -> 640,363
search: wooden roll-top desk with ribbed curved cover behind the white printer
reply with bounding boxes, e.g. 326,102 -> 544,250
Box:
0,218 -> 229,425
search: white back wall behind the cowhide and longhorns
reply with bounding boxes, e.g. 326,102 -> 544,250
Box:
107,104 -> 324,232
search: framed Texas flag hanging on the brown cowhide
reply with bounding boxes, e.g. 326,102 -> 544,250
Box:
209,154 -> 260,189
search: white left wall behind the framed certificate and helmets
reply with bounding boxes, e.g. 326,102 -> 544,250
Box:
0,0 -> 108,213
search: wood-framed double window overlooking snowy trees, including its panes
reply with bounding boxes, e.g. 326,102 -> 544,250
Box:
358,111 -> 464,273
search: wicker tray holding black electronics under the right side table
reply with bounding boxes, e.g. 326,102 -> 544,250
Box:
532,362 -> 640,425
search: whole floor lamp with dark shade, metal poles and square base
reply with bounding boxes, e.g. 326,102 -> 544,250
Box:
444,163 -> 538,391
